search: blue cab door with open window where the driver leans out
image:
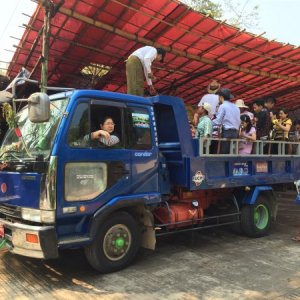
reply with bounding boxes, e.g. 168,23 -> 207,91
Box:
57,99 -> 132,223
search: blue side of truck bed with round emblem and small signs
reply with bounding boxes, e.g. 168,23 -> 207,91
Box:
160,139 -> 300,190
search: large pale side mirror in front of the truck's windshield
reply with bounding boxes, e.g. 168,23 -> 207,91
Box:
28,93 -> 50,123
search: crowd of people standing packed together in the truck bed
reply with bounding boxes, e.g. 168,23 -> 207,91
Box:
190,80 -> 300,154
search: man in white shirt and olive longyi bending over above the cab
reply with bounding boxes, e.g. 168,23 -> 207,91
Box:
126,46 -> 166,96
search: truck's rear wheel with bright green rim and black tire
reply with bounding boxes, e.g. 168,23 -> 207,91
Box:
241,196 -> 271,237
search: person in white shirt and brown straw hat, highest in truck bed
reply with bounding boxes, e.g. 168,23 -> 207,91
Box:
194,80 -> 221,125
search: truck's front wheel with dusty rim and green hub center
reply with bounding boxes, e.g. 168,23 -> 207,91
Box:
85,212 -> 141,273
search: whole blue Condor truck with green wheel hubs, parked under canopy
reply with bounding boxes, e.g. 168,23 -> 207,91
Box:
0,90 -> 300,272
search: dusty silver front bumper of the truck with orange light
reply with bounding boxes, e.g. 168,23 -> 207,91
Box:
0,219 -> 58,259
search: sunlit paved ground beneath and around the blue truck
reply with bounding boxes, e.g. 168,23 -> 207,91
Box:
0,192 -> 300,300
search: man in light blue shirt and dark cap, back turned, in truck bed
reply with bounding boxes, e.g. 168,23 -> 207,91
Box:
213,88 -> 241,154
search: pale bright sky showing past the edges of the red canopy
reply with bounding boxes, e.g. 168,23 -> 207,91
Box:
0,0 -> 300,72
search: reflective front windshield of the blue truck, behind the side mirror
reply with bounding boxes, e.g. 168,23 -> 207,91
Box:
0,98 -> 69,160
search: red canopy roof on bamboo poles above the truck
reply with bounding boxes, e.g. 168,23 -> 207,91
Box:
8,0 -> 300,109
